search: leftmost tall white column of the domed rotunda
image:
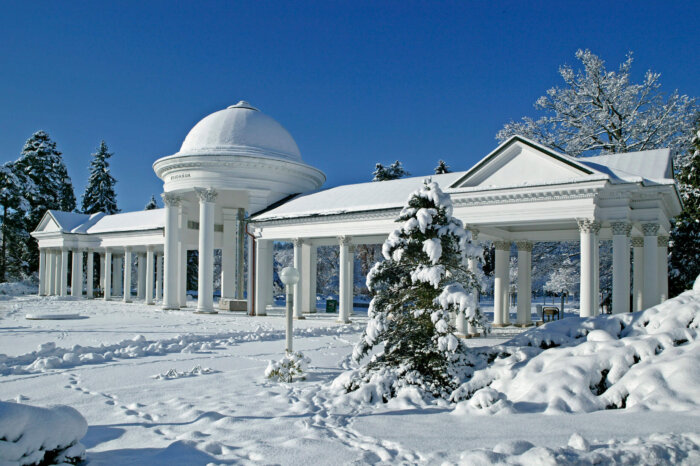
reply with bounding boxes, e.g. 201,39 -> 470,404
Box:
161,193 -> 180,309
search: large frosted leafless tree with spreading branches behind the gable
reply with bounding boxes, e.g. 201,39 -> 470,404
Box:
496,50 -> 696,165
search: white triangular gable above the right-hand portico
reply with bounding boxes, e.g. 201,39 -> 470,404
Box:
450,136 -> 599,188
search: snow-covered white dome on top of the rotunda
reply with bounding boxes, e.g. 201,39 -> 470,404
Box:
176,101 -> 301,162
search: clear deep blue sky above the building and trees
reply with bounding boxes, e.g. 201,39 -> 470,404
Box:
0,0 -> 700,210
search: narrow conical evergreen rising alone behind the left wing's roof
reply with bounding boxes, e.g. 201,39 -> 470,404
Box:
83,141 -> 119,215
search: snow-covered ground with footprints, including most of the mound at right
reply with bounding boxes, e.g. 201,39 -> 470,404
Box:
0,295 -> 700,465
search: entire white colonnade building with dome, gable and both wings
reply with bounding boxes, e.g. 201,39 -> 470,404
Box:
32,102 -> 682,333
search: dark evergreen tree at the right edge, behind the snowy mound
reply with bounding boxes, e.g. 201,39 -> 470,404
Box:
669,118 -> 700,296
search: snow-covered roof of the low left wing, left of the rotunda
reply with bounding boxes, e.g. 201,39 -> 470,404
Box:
39,209 -> 165,233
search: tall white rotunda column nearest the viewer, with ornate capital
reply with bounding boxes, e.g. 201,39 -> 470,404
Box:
195,188 -> 218,312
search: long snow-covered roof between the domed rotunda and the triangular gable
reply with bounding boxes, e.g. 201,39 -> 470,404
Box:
253,172 -> 464,220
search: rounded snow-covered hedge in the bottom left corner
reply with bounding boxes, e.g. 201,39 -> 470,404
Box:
0,401 -> 87,465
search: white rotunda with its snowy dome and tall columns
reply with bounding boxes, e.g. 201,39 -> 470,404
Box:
153,101 -> 326,312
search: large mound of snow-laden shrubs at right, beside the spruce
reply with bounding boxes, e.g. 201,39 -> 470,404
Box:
453,291 -> 700,414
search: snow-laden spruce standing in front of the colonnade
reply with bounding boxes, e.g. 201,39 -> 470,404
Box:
345,180 -> 480,401
